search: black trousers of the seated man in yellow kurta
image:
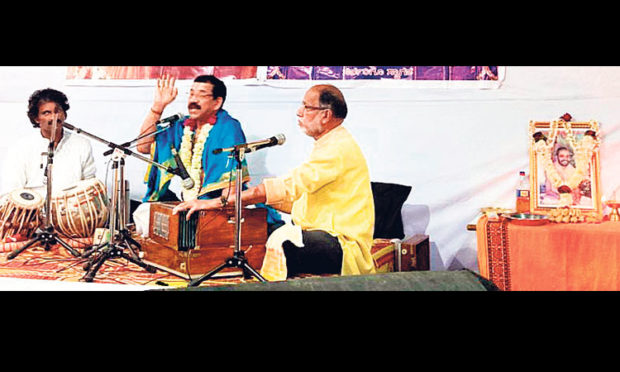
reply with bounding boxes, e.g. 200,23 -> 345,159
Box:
282,230 -> 342,277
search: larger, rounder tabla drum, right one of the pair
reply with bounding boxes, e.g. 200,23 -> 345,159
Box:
50,178 -> 109,238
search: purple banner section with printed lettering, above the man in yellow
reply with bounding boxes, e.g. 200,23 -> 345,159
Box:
267,66 -> 498,80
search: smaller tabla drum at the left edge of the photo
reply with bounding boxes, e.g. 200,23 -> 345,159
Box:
0,189 -> 44,243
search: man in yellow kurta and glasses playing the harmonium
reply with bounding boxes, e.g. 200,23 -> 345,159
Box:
173,85 -> 375,280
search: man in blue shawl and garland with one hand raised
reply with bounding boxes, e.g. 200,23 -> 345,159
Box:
137,75 -> 283,232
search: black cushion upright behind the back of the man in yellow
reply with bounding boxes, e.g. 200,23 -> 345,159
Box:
370,182 -> 412,239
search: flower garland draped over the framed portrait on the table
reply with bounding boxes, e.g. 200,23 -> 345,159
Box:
531,120 -> 600,206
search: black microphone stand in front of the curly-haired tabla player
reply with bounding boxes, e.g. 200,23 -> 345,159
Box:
7,125 -> 80,260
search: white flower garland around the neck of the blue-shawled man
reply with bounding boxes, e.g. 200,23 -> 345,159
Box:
179,119 -> 215,200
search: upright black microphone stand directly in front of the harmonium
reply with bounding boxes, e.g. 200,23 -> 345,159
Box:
188,146 -> 267,287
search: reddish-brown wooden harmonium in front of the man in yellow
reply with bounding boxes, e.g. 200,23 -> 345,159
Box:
141,202 -> 267,279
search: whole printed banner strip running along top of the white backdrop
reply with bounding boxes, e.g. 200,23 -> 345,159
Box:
66,66 -> 504,88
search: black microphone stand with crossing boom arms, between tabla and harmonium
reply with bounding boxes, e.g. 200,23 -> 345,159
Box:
63,123 -> 179,282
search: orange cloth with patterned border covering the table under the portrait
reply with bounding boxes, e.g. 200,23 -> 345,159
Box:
476,216 -> 620,291
